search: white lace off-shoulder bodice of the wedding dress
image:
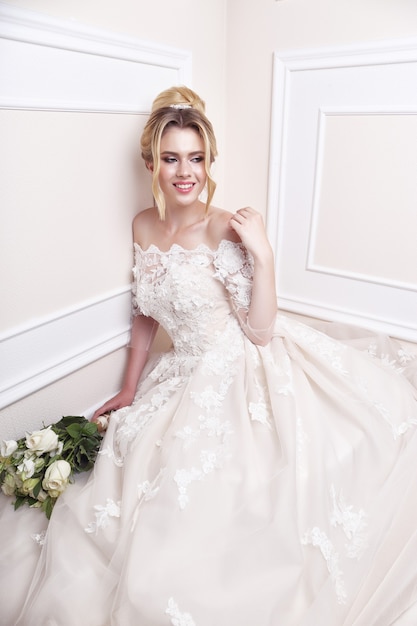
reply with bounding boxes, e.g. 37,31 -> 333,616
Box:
133,240 -> 253,355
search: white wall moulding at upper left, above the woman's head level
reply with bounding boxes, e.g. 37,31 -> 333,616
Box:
0,3 -> 191,113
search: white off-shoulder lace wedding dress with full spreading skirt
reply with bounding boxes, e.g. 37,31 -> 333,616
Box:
0,241 -> 417,626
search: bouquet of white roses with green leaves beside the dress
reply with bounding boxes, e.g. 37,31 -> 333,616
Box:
0,416 -> 101,519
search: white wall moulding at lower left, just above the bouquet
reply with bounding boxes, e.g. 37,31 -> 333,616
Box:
0,288 -> 130,409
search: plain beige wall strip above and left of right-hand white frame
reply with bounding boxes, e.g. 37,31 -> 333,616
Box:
226,0 -> 417,211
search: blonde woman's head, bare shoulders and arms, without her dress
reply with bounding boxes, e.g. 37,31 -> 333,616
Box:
93,88 -> 277,420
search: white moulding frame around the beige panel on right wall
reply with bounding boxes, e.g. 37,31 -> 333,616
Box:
267,39 -> 417,341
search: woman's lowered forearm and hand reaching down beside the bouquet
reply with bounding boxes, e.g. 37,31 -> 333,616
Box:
92,315 -> 158,422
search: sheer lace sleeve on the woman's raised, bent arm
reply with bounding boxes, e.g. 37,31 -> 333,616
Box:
214,241 -> 276,345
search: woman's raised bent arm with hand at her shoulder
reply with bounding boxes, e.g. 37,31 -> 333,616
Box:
230,207 -> 278,345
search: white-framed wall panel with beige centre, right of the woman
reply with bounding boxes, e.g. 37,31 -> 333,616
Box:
267,40 -> 417,342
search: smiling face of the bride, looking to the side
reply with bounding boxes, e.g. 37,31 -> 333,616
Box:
159,126 -> 207,208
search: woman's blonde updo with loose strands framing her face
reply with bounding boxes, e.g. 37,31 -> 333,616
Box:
141,87 -> 217,220
